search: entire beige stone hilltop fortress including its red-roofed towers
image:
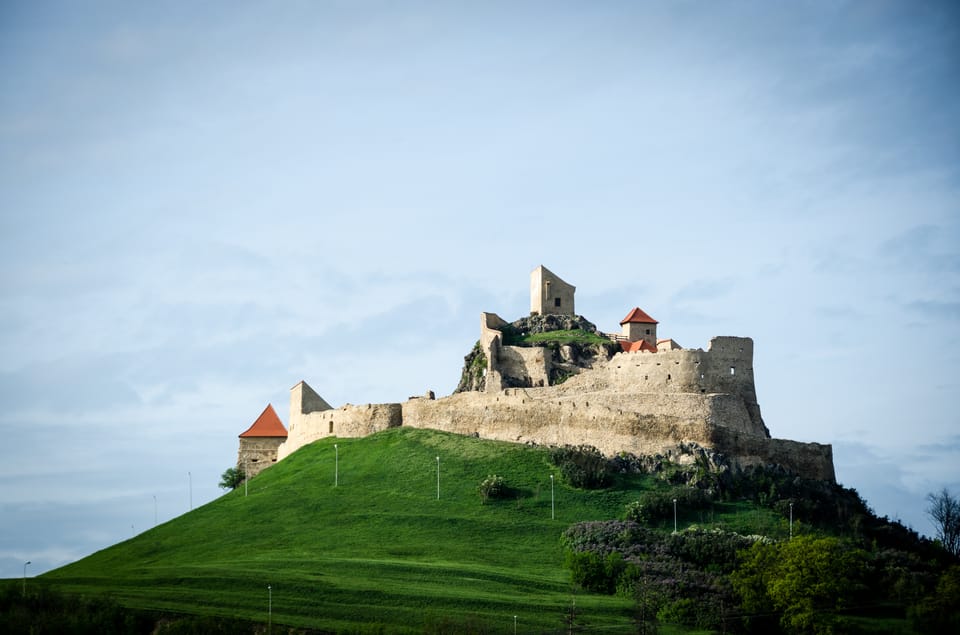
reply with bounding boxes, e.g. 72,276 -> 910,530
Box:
238,266 -> 835,481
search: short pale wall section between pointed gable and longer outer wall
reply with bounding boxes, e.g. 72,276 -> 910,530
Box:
277,400 -> 402,460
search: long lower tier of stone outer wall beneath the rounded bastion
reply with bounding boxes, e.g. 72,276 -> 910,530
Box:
402,388 -> 835,481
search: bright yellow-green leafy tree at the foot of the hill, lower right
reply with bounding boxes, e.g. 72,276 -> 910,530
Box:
731,536 -> 866,633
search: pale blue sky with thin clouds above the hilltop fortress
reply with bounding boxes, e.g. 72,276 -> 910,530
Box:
0,2 -> 960,577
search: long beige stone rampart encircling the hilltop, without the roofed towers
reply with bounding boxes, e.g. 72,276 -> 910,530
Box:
278,336 -> 835,481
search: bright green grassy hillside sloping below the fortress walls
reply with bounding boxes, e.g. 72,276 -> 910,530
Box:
42,428 -> 781,633
